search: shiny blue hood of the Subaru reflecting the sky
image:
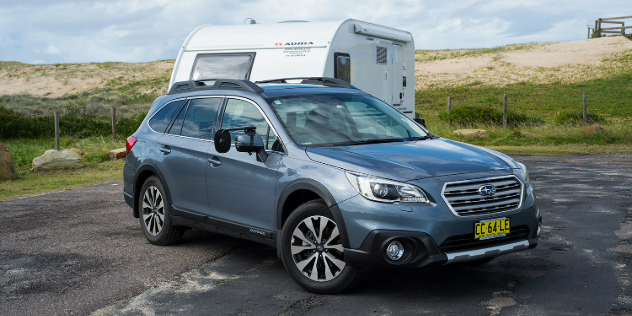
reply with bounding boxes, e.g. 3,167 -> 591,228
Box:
306,139 -> 519,181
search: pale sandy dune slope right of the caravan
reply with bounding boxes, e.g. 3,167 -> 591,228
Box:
415,36 -> 632,88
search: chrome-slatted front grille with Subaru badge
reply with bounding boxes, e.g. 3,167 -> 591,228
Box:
441,176 -> 523,217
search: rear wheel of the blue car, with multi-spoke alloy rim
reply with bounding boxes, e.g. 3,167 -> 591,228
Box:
138,176 -> 184,246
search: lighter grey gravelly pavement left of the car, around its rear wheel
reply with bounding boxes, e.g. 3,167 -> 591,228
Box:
0,181 -> 240,315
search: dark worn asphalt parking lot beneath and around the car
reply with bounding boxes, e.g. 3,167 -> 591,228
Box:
0,154 -> 632,315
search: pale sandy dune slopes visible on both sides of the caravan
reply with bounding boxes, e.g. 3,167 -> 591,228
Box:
0,36 -> 632,97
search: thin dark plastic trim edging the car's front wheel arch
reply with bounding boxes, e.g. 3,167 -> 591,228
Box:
276,179 -> 349,248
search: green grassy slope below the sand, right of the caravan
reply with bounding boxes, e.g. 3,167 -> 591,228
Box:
415,72 -> 632,120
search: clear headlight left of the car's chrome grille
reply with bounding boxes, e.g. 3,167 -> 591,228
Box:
346,172 -> 430,203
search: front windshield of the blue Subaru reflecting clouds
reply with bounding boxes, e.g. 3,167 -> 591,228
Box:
268,94 -> 427,147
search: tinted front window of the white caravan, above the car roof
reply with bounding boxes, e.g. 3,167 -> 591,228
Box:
191,53 -> 255,80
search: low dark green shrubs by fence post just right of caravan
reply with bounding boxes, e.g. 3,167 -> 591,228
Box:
439,105 -> 544,126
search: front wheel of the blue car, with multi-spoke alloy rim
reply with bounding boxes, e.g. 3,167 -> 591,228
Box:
281,200 -> 364,294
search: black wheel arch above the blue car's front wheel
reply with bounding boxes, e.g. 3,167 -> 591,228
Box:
276,179 -> 349,248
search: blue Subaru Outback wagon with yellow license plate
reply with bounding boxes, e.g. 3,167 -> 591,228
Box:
124,78 -> 541,293
